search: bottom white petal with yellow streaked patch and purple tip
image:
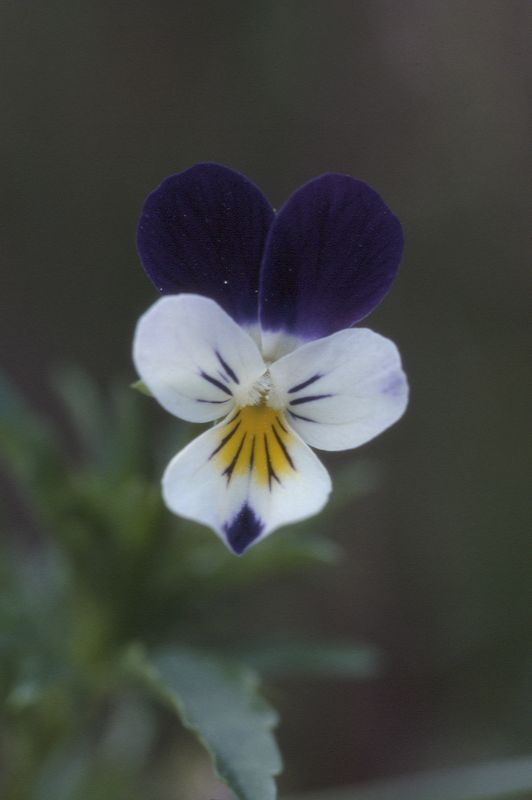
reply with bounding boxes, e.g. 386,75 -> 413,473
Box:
163,406 -> 331,553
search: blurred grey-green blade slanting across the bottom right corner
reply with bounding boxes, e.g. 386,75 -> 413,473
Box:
284,757 -> 532,800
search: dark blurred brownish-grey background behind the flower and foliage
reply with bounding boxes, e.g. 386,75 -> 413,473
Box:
0,0 -> 532,790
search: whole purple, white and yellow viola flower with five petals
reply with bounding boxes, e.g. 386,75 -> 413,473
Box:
133,164 -> 408,554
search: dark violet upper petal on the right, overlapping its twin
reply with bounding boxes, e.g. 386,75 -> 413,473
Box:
260,174 -> 403,339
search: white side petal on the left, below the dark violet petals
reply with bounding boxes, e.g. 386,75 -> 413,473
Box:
133,294 -> 265,422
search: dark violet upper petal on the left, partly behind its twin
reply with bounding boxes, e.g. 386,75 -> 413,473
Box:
137,164 -> 273,323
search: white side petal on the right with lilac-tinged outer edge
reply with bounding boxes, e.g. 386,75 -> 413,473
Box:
270,328 -> 408,450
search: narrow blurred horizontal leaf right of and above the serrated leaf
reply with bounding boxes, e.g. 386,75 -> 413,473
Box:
235,639 -> 379,679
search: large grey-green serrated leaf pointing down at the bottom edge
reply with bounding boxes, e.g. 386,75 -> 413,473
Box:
129,647 -> 282,800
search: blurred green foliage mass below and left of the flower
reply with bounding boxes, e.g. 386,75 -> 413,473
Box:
0,369 -> 377,800
